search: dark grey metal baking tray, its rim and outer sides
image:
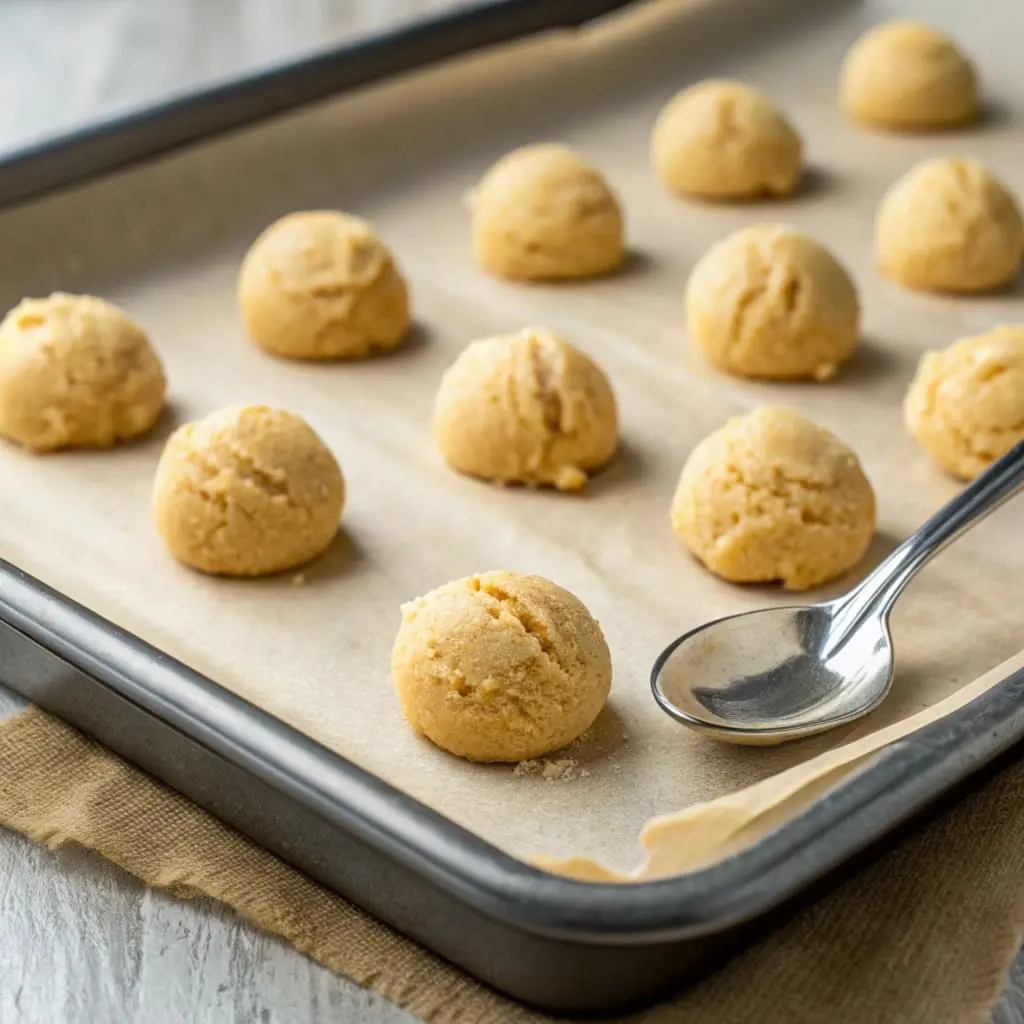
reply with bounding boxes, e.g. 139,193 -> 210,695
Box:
0,0 -> 1024,1014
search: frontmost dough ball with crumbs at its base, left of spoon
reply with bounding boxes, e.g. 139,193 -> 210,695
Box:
391,572 -> 611,761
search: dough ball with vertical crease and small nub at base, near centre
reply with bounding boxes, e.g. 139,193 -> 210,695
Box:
434,328 -> 618,490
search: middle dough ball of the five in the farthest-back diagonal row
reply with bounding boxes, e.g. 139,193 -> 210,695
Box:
468,142 -> 623,281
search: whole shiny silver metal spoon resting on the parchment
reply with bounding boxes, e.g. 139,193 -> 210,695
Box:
651,441 -> 1024,743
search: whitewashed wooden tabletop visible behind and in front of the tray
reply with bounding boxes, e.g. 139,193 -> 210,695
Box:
0,0 -> 1024,1024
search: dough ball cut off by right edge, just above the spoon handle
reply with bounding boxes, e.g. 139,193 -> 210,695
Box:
903,324 -> 1024,479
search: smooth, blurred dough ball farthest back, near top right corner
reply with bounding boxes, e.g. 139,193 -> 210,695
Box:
840,20 -> 978,129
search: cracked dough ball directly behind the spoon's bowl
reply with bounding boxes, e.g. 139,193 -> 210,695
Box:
672,409 -> 874,590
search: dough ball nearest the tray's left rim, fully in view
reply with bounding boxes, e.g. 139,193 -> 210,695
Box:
153,406 -> 345,577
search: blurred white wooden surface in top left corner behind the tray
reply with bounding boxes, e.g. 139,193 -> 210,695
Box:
0,0 -> 480,148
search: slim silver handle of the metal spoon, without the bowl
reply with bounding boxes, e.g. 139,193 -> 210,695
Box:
834,441 -> 1024,635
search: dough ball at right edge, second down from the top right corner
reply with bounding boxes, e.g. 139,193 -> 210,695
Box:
874,158 -> 1024,292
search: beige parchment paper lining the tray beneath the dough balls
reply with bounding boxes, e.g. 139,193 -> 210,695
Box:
0,0 -> 1024,868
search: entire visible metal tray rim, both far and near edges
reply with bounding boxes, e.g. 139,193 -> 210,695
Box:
0,0 -> 1024,999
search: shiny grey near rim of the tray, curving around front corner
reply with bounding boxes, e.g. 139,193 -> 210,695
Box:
0,559 -> 1024,945
